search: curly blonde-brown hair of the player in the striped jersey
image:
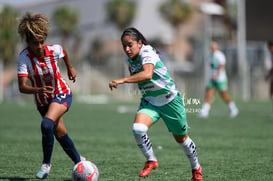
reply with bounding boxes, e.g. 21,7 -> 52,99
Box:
18,12 -> 49,42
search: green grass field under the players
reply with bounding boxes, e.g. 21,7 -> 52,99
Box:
0,100 -> 273,181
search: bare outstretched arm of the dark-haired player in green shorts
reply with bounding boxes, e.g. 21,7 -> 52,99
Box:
109,63 -> 154,90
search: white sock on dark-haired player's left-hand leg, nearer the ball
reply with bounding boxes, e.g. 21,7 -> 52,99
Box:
133,123 -> 157,161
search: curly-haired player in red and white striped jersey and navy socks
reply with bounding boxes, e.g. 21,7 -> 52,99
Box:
17,13 -> 84,179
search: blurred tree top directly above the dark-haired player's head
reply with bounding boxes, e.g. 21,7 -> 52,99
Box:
106,0 -> 136,30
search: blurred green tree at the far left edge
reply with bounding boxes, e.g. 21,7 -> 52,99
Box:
0,6 -> 17,65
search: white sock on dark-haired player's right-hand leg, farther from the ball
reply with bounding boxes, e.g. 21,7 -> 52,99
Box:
179,137 -> 200,170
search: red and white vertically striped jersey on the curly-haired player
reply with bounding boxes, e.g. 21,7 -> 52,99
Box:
17,45 -> 71,106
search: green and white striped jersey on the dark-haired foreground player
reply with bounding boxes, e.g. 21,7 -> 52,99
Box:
127,45 -> 178,106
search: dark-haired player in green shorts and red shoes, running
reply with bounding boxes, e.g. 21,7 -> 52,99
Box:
109,28 -> 203,181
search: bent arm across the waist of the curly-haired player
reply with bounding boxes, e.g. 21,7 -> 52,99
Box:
18,76 -> 53,96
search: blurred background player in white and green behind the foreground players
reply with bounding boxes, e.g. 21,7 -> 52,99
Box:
199,42 -> 239,118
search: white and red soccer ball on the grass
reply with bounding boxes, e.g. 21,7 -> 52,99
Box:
72,160 -> 99,181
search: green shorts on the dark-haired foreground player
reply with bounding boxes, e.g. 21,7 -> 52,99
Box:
137,94 -> 188,135
